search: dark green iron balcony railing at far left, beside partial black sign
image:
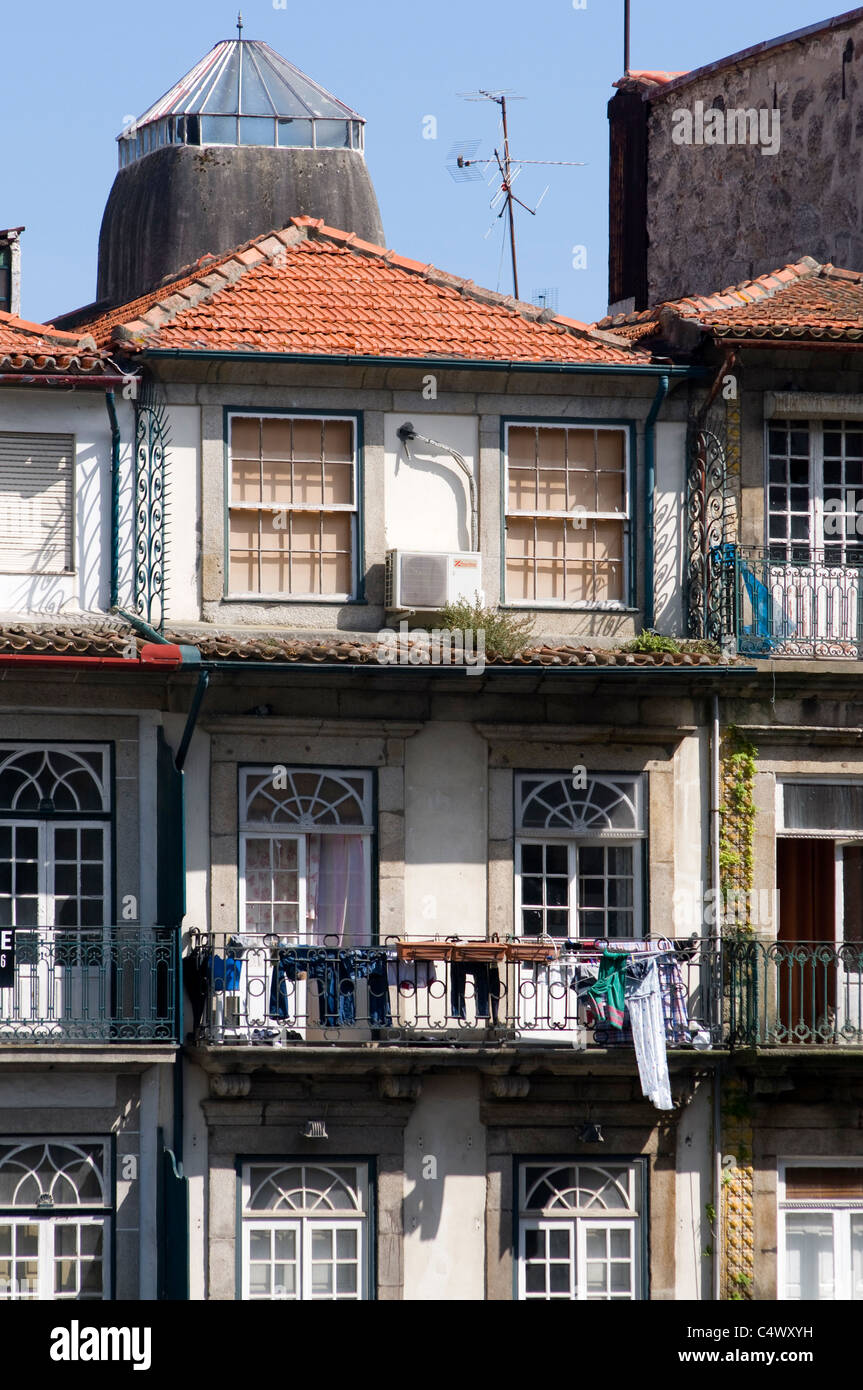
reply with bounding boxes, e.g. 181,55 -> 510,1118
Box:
0,927 -> 178,1048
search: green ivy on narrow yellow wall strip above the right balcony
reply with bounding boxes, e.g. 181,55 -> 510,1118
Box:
720,724 -> 757,933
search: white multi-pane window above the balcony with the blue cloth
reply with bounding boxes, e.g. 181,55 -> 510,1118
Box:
767,420 -> 863,566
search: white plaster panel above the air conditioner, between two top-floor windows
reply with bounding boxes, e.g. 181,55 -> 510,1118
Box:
384,410 -> 478,550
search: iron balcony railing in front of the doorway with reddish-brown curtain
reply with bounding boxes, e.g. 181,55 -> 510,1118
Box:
724,941 -> 863,1047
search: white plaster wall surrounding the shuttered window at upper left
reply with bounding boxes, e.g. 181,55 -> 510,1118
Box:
0,386 -> 135,617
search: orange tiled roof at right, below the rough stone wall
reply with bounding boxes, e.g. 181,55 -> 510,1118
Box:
596,256 -> 863,345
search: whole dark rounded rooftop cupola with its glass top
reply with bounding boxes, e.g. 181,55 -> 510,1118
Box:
96,31 -> 384,303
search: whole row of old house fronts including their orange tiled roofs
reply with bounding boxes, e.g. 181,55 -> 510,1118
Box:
0,24 -> 863,1301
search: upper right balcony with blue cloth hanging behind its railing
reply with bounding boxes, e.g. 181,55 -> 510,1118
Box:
710,543 -> 863,660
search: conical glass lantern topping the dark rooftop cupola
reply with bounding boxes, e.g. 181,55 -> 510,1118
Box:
117,38 -> 365,168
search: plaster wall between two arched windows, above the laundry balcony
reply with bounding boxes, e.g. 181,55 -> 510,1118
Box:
404,721 -> 488,938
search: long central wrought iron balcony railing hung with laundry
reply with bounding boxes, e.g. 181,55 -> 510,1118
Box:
183,933 -> 723,1048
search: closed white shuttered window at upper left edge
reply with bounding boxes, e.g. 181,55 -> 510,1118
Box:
0,432 -> 75,574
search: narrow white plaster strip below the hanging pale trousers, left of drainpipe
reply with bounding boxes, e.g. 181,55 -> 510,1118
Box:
674,1081 -> 716,1300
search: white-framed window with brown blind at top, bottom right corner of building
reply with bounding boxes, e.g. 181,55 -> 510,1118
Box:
778,1159 -> 863,1301
